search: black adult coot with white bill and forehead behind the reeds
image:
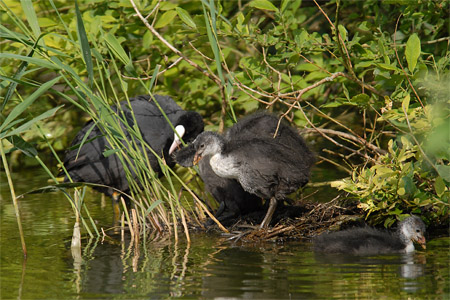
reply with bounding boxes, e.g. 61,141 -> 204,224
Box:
61,95 -> 204,204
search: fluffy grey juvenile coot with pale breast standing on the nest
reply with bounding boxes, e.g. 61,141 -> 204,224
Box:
183,131 -> 310,227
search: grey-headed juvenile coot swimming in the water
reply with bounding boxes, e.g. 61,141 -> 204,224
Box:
314,216 -> 426,255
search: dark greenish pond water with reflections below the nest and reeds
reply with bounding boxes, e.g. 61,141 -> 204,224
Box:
0,171 -> 450,299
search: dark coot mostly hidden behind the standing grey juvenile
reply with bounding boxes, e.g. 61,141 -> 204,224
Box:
176,112 -> 314,222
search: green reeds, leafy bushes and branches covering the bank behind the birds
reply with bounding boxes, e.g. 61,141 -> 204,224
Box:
0,0 -> 450,244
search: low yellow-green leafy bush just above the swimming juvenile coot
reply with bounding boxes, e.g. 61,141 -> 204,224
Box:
332,136 -> 450,226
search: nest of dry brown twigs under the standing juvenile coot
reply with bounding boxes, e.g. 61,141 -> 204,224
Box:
221,196 -> 363,242
